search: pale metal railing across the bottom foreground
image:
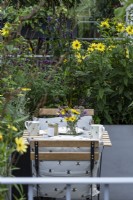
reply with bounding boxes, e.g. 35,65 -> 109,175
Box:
0,177 -> 133,200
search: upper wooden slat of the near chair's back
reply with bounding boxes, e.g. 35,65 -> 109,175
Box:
30,139 -> 99,147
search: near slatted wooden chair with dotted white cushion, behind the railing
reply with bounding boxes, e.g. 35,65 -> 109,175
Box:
29,138 -> 100,200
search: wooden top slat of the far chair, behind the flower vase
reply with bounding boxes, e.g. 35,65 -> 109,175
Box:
39,108 -> 94,116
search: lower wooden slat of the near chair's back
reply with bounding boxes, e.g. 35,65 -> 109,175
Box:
31,152 -> 99,161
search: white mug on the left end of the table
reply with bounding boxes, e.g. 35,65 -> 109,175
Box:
25,121 -> 40,135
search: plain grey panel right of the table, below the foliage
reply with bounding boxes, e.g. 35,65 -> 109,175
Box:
100,125 -> 133,200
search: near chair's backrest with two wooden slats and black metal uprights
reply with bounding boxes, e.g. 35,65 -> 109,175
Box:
30,138 -> 99,171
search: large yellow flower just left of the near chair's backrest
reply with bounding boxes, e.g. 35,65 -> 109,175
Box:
15,137 -> 27,154
